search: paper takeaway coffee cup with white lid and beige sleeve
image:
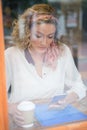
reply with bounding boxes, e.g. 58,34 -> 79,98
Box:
17,101 -> 35,127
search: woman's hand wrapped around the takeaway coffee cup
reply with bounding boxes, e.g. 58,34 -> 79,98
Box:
8,103 -> 24,126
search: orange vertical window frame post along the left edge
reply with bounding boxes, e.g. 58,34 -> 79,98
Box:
0,0 -> 9,130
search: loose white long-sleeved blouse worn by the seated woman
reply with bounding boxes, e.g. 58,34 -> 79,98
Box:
5,45 -> 86,102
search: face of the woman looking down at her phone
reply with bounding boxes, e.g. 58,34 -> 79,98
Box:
30,23 -> 56,54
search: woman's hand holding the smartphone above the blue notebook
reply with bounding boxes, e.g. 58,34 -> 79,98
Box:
49,92 -> 79,110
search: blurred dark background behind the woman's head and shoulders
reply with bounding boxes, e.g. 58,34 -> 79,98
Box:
2,0 -> 87,85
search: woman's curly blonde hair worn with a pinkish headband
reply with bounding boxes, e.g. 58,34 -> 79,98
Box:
12,4 -> 58,49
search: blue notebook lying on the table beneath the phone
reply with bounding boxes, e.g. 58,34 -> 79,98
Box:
35,96 -> 87,126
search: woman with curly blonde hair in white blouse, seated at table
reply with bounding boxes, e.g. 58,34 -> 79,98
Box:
5,4 -> 86,125
